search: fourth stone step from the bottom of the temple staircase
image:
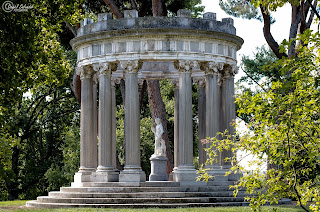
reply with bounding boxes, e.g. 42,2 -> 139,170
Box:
60,186 -> 238,193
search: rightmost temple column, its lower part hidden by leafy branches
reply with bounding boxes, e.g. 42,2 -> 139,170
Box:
220,65 -> 238,169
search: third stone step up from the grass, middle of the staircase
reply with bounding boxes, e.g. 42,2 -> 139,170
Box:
49,191 -> 245,198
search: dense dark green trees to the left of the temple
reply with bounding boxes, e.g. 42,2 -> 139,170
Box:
0,0 -> 81,199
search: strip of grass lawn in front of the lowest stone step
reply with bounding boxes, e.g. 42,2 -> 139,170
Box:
0,200 -> 303,212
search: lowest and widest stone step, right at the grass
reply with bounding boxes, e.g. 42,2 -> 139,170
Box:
26,201 -> 249,210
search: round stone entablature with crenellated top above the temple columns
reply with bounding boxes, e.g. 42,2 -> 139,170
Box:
71,11 -> 243,78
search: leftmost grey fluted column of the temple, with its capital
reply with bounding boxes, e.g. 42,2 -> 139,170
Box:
78,66 -> 97,172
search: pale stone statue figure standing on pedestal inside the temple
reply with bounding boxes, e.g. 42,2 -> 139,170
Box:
151,118 -> 166,156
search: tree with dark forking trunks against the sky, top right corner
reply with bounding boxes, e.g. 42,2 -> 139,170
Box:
219,0 -> 320,59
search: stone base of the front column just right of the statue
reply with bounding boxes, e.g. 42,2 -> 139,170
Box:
173,166 -> 199,182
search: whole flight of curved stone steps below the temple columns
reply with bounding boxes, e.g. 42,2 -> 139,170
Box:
27,181 -> 255,208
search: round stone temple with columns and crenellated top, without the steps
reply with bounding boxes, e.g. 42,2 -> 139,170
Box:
71,10 -> 243,184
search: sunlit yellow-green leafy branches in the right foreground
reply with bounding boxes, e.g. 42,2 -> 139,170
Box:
201,31 -> 320,211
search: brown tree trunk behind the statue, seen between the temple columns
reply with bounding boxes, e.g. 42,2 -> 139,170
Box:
147,80 -> 173,174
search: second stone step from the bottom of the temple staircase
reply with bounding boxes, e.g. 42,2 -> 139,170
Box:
37,196 -> 244,204
